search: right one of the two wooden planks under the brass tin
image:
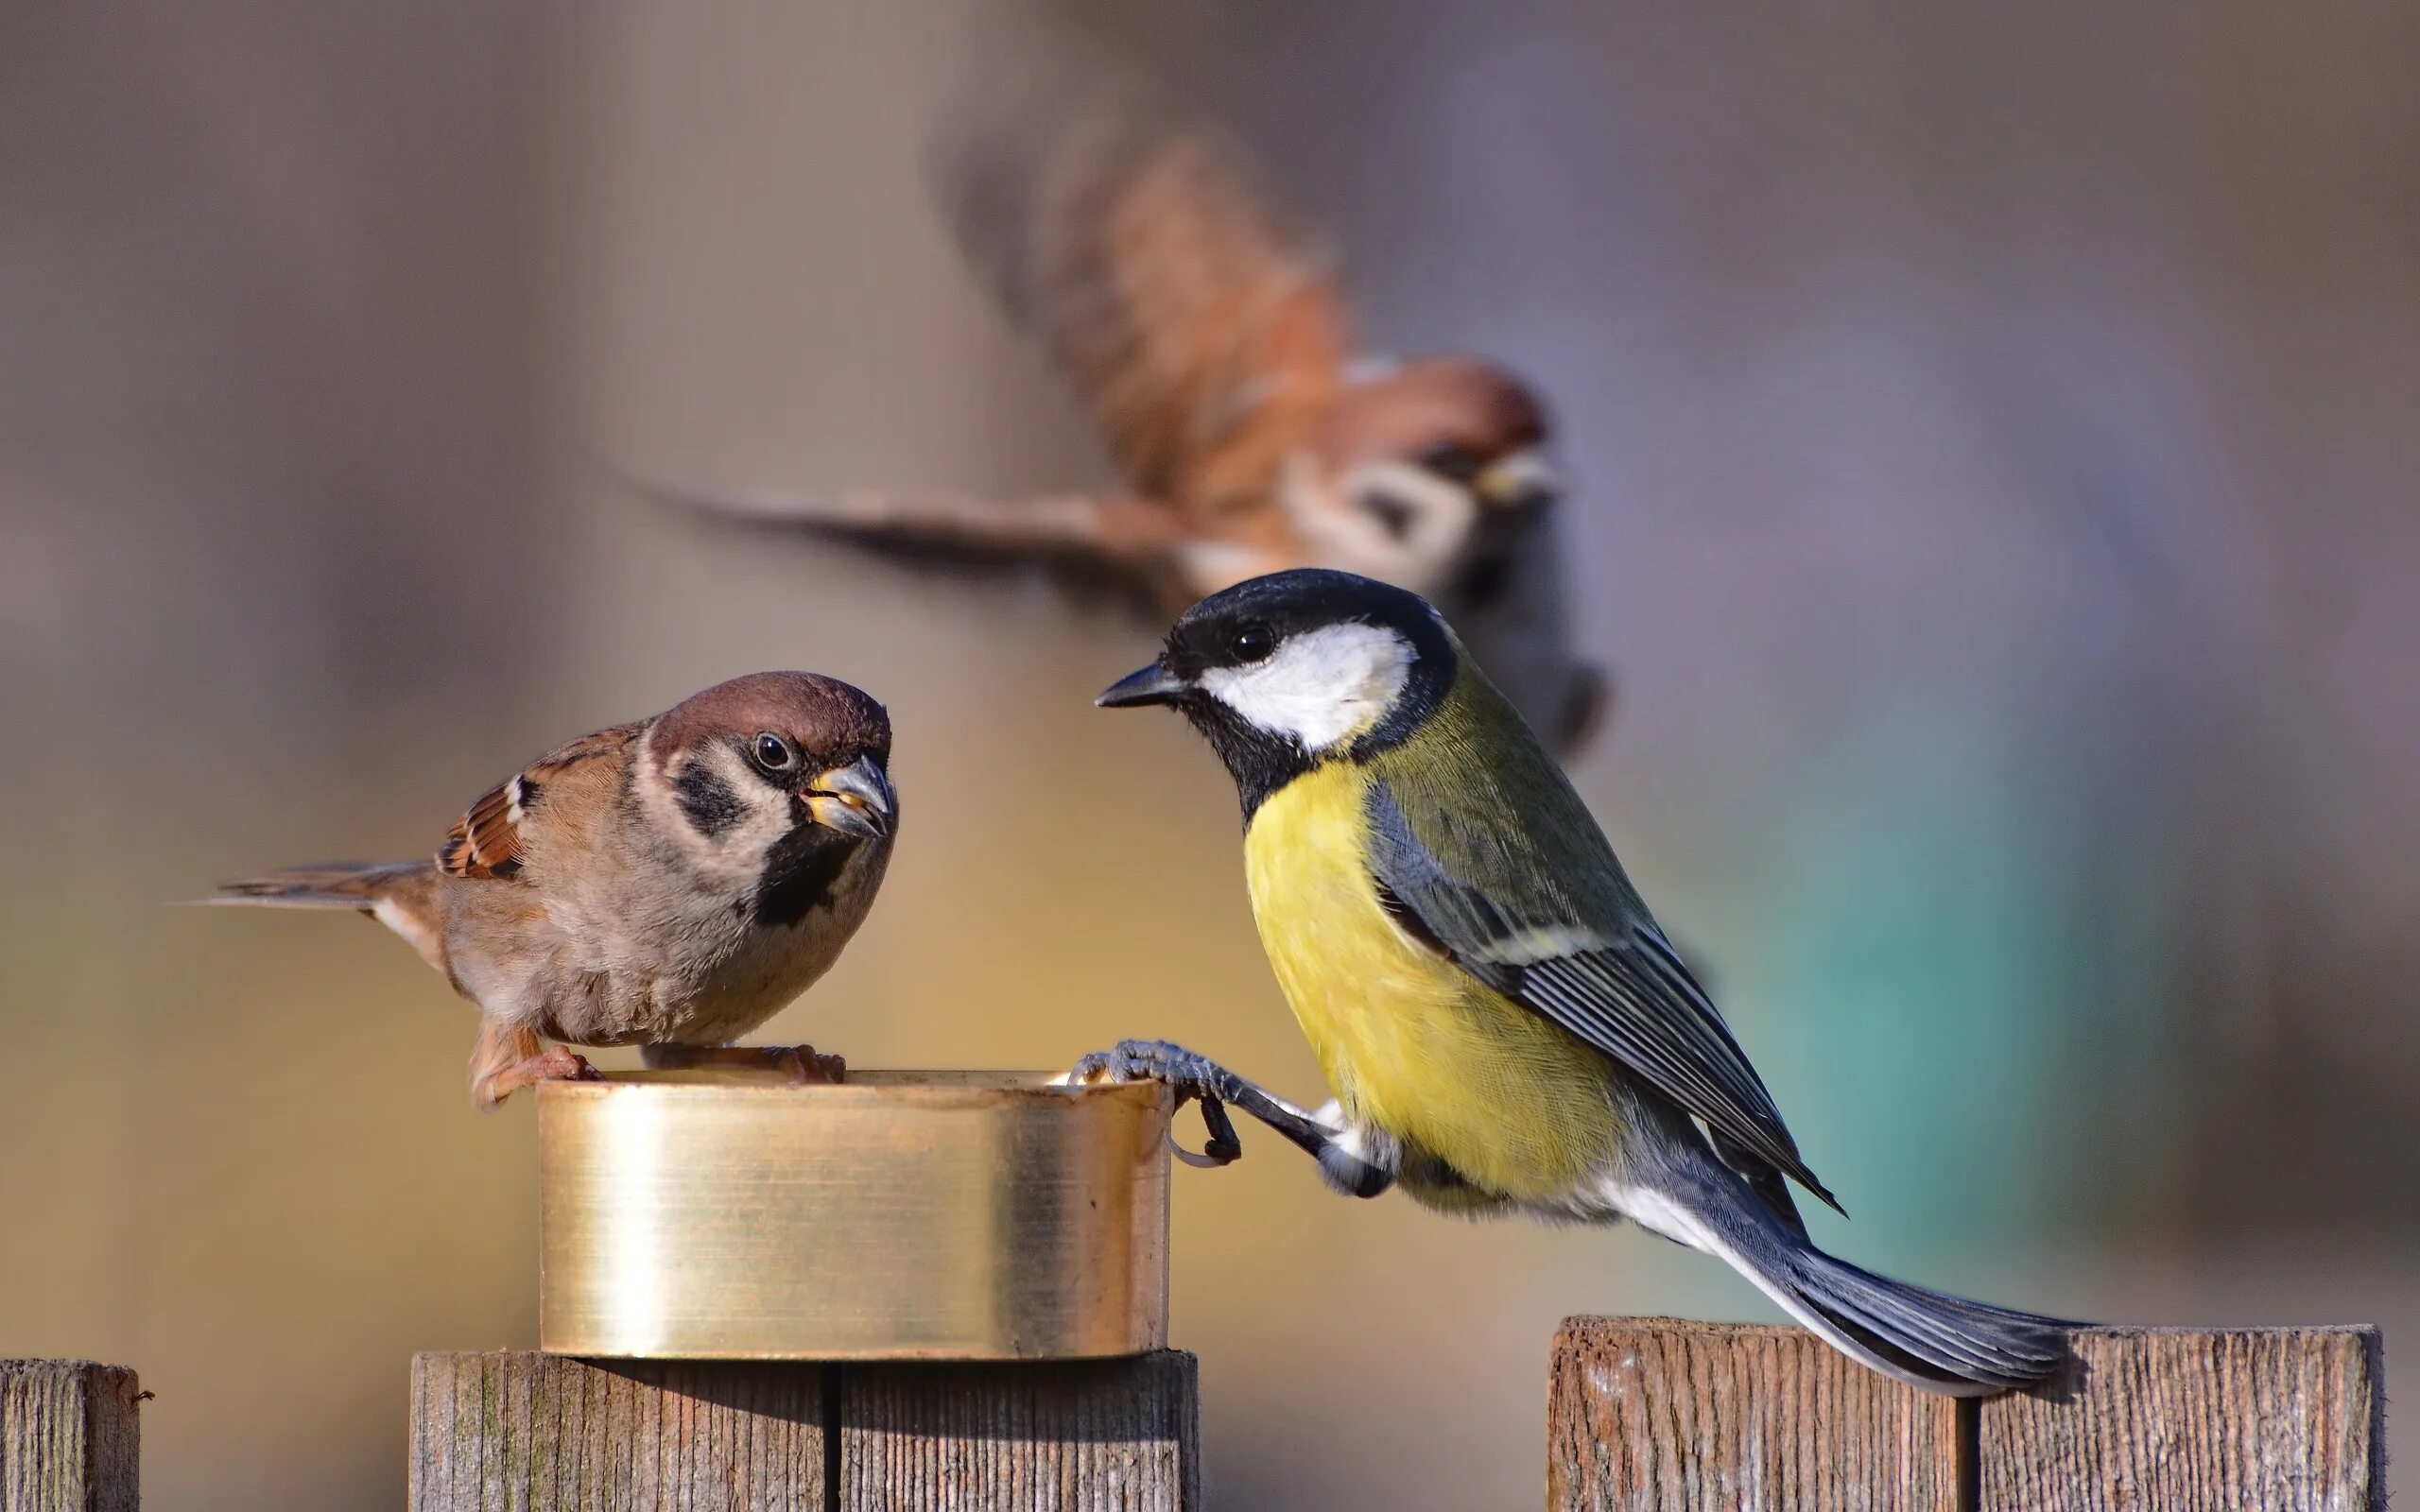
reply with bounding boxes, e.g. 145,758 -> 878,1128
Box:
838,1349 -> 1201,1512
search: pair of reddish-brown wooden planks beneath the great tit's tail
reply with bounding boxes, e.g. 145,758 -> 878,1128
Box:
1547,1318 -> 2386,1512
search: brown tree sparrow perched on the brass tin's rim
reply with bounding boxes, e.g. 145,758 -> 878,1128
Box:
208,673 -> 898,1108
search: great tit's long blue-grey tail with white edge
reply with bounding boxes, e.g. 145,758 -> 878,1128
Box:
1619,1132 -> 2079,1396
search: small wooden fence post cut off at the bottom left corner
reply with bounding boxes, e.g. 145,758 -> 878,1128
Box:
0,1360 -> 143,1512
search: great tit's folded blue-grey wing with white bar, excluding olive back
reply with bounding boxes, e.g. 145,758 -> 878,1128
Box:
1367,782 -> 1840,1210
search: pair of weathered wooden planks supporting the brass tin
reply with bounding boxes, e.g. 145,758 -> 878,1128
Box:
409,1349 -> 1201,1512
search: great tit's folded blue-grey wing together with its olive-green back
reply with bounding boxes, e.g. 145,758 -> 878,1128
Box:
1365,745 -> 1840,1207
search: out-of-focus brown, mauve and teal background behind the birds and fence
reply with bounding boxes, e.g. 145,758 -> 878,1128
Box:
0,0 -> 2420,1507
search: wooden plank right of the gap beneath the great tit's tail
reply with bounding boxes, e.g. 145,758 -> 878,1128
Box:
1978,1328 -> 2386,1512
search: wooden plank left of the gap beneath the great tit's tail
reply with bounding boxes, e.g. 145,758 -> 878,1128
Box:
1547,1318 -> 1961,1512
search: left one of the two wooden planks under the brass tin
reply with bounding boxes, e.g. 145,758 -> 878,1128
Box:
409,1349 -> 828,1512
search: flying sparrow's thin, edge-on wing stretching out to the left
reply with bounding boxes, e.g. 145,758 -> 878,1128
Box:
622,474 -> 1181,569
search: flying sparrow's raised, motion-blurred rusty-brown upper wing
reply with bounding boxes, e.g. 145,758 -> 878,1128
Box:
934,58 -> 1350,512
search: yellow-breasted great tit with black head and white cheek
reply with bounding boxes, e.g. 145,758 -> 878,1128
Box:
1075,569 -> 2071,1396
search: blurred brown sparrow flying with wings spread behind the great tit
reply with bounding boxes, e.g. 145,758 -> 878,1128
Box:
631,58 -> 1604,750
